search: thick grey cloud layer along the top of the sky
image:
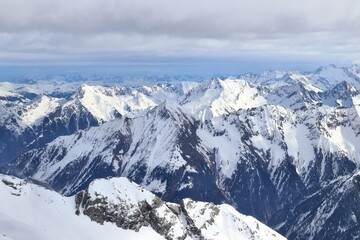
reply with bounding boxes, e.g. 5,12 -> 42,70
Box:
0,0 -> 360,38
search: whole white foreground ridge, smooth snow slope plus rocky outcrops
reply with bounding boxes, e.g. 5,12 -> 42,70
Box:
0,175 -> 285,240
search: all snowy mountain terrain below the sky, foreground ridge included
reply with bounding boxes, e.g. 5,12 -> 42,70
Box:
0,65 -> 360,240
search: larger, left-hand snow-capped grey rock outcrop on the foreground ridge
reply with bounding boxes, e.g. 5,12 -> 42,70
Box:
76,178 -> 187,239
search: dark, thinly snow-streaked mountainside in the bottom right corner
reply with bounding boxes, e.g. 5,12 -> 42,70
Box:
270,172 -> 360,240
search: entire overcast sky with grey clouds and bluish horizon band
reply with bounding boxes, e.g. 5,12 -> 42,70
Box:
0,0 -> 360,75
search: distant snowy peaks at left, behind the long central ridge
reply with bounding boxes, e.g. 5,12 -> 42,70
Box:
0,81 -> 197,165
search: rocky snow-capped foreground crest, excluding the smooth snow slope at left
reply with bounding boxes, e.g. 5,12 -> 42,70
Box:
75,178 -> 283,240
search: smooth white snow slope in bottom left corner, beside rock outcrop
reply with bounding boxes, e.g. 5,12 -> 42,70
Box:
0,175 -> 163,240
